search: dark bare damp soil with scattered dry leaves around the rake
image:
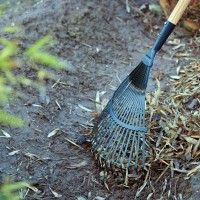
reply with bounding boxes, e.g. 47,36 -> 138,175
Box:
0,0 -> 198,200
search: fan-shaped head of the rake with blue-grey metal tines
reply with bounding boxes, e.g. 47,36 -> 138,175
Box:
92,62 -> 150,168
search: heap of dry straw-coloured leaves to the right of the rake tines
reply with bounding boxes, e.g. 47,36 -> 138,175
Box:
147,61 -> 200,172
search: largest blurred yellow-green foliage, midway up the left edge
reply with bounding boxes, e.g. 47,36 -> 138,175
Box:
0,36 -> 68,127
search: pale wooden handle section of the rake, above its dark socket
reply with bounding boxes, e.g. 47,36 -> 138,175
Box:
168,0 -> 191,25
